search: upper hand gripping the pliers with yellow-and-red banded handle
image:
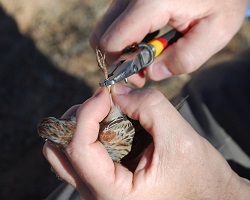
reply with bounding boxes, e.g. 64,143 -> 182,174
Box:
90,0 -> 248,87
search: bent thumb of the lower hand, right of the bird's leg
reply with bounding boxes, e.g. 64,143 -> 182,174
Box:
112,84 -> 197,185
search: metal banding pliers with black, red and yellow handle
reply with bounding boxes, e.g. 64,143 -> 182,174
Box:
99,29 -> 182,86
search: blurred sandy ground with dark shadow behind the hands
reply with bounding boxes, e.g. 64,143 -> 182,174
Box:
0,0 -> 250,200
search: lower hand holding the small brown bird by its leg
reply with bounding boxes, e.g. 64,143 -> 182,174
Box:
44,84 -> 250,199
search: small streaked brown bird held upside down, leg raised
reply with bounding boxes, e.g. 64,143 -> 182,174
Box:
38,49 -> 152,162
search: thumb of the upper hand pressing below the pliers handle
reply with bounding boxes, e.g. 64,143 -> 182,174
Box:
146,16 -> 240,81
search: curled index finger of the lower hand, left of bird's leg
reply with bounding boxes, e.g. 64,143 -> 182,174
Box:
66,88 -> 132,199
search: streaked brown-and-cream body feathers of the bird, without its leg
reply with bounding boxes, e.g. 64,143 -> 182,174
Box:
38,102 -> 135,162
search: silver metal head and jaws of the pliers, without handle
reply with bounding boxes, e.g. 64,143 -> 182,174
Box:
99,43 -> 154,86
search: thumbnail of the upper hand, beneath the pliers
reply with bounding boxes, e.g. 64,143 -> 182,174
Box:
152,61 -> 173,80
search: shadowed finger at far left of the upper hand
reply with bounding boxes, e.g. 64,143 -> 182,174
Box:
89,0 -> 129,49
